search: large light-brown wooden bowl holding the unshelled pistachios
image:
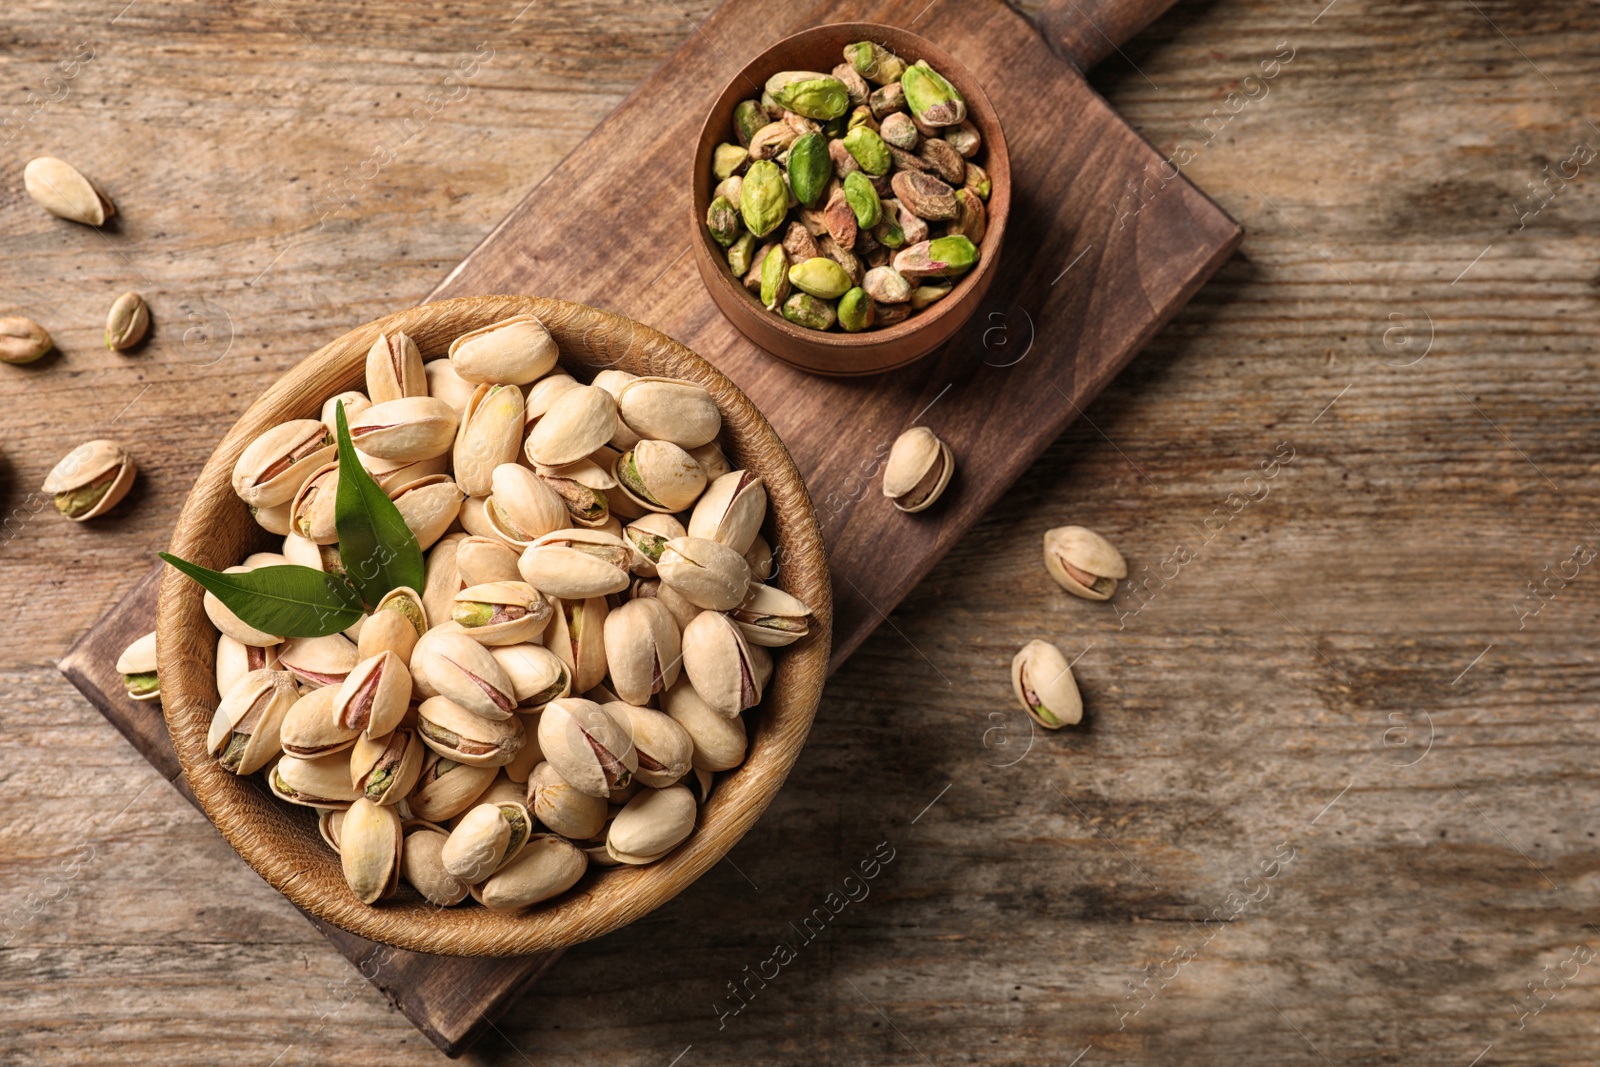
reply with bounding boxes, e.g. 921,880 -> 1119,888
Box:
157,296 -> 832,957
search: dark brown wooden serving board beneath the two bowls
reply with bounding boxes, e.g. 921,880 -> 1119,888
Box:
61,0 -> 1242,1056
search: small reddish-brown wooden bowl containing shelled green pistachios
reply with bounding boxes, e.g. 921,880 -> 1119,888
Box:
691,22 -> 1011,376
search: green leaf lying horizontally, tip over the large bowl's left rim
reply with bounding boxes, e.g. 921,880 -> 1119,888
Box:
158,552 -> 362,637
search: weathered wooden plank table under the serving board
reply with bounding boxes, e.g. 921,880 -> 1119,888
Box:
0,0 -> 1600,1067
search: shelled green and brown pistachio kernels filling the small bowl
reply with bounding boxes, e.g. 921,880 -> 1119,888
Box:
706,42 -> 990,333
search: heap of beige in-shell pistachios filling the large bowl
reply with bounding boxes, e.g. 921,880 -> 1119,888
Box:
157,315 -> 811,910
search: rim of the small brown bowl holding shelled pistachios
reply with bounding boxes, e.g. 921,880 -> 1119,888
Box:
690,21 -> 1011,355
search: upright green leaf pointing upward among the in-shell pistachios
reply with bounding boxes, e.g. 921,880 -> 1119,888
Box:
333,402 -> 424,606
